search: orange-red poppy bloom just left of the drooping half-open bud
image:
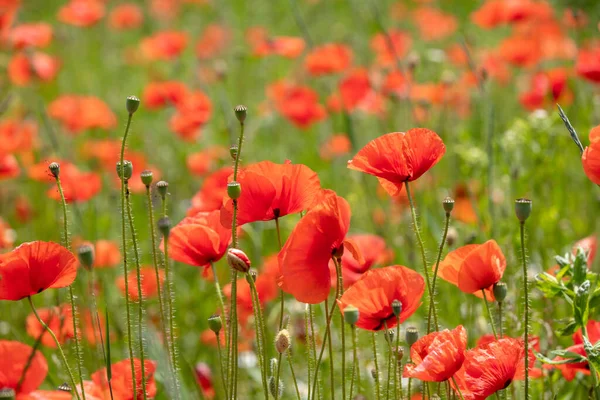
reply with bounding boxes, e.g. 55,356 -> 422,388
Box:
169,211 -> 231,267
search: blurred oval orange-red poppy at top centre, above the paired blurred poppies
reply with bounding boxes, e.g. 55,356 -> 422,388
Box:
304,43 -> 352,76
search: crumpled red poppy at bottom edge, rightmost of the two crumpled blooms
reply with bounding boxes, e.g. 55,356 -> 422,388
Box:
451,338 -> 525,400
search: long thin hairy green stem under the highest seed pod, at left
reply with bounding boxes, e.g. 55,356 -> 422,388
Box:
119,113 -> 137,393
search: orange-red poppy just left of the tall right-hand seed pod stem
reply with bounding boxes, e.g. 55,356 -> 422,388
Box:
433,240 -> 506,301
